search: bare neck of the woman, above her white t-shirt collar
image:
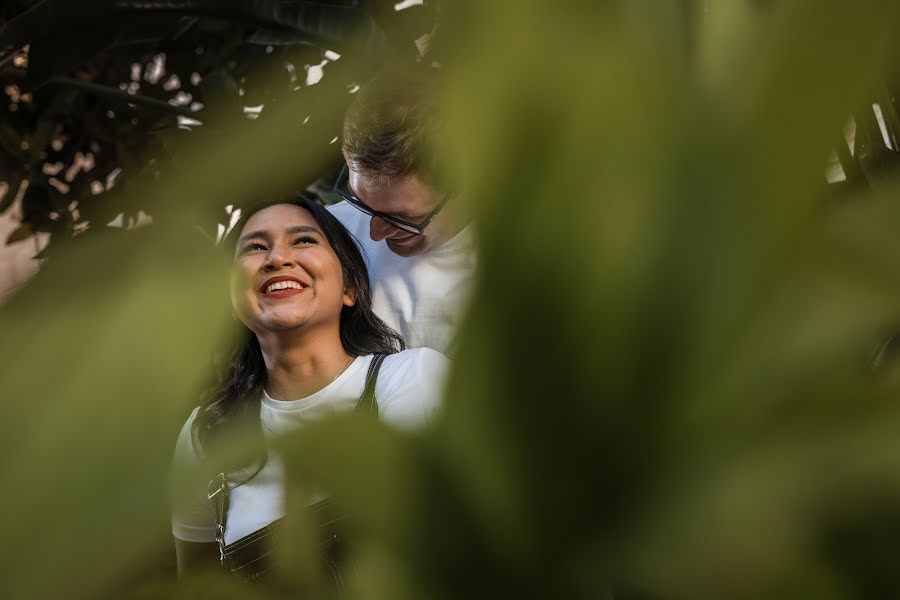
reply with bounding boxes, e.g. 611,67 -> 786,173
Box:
257,331 -> 353,400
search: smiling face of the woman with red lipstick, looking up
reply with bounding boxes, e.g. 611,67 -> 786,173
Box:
231,204 -> 355,335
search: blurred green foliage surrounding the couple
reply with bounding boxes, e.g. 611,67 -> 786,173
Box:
0,0 -> 900,599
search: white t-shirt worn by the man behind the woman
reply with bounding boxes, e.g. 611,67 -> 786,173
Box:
328,202 -> 476,356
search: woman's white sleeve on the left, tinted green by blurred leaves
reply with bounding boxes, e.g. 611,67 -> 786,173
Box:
169,407 -> 216,542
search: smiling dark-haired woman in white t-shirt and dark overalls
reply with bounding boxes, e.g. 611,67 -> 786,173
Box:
172,199 -> 447,580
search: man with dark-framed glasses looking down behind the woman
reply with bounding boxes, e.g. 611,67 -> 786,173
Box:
329,67 -> 475,354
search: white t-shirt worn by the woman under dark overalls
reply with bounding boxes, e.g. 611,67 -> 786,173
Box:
172,348 -> 448,544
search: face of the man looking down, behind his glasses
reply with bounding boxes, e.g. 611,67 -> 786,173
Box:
349,168 -> 458,256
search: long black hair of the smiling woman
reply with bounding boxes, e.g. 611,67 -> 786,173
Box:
193,196 -> 405,454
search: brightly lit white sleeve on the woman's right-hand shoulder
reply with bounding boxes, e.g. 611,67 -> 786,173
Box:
375,348 -> 450,430
